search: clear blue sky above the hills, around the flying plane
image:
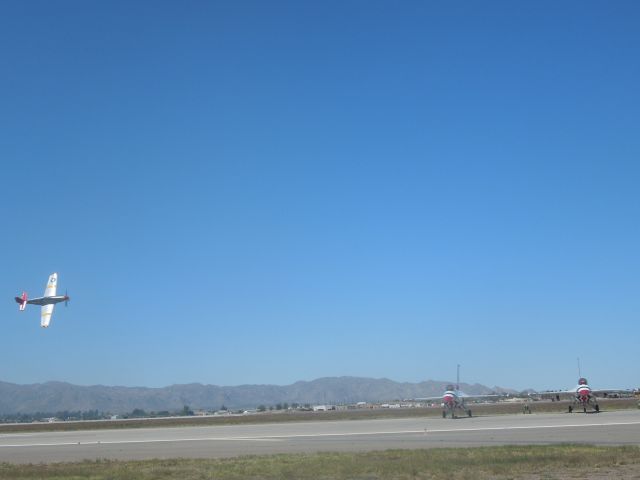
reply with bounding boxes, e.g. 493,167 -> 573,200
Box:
0,0 -> 640,388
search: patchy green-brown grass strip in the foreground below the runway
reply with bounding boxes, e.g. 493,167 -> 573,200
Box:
0,445 -> 640,480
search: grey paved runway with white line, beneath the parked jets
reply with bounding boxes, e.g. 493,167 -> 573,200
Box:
0,410 -> 640,463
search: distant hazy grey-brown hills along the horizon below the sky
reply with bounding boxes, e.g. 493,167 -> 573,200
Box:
0,377 -> 515,415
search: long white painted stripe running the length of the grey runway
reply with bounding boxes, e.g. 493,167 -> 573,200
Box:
0,421 -> 640,448
